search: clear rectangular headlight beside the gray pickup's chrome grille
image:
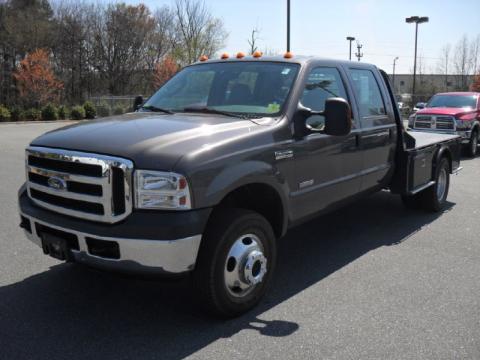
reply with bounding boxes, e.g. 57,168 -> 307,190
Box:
135,170 -> 191,210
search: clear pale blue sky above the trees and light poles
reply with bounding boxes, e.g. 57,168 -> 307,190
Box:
127,0 -> 480,73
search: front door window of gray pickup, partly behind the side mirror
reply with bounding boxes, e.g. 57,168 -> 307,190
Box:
300,67 -> 347,130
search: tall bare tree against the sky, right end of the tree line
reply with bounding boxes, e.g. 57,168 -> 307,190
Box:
174,0 -> 227,65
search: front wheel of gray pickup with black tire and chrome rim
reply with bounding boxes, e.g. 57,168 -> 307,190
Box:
193,208 -> 276,318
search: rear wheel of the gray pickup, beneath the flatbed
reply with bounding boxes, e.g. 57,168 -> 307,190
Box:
419,157 -> 450,212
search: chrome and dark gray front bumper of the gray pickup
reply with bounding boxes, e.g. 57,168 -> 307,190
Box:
19,191 -> 211,275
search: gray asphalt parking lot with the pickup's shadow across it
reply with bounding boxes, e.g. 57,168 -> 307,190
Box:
0,123 -> 480,360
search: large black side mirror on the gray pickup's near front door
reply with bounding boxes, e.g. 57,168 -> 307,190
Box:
297,98 -> 352,136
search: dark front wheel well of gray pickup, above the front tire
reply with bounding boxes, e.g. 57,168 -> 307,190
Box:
216,183 -> 284,238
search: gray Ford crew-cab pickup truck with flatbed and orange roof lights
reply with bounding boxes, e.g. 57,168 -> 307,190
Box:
18,57 -> 460,317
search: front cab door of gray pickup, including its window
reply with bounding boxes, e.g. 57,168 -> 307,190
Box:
291,66 -> 363,218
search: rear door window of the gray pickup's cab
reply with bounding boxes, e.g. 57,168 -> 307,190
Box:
350,69 -> 387,118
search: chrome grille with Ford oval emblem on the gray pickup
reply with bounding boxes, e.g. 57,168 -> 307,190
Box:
25,147 -> 133,223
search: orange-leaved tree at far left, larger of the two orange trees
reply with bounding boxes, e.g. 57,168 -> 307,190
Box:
13,49 -> 63,106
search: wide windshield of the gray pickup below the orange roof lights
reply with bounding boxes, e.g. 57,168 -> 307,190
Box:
144,61 -> 299,117
